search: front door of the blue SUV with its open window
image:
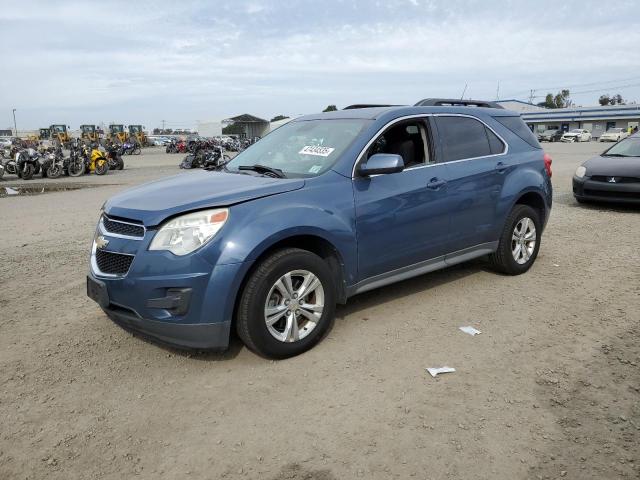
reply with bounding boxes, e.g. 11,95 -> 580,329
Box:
353,119 -> 449,281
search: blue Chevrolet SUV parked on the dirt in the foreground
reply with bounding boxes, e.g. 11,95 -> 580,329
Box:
87,99 -> 552,358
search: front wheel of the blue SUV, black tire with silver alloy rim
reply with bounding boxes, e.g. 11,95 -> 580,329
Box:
236,248 -> 336,358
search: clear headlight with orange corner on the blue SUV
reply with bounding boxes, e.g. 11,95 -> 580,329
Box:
149,208 -> 229,255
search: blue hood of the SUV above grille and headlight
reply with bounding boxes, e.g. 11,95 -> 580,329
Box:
104,170 -> 305,226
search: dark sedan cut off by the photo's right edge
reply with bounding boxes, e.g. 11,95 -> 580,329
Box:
573,134 -> 640,205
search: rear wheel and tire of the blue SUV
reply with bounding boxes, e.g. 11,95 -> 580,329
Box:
489,205 -> 542,275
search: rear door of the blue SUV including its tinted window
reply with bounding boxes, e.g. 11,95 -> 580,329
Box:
434,114 -> 509,253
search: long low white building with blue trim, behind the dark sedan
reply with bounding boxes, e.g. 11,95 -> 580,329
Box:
498,100 -> 640,139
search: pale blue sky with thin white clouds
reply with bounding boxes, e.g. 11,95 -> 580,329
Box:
0,0 -> 640,130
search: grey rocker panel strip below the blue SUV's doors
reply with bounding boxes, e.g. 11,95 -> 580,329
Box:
347,241 -> 498,297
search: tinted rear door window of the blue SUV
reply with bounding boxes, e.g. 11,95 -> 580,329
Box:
436,117 -> 491,162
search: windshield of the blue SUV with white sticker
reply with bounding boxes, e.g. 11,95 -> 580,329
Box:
226,119 -> 369,177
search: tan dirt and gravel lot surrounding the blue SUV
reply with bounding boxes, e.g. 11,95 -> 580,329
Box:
0,143 -> 640,480
